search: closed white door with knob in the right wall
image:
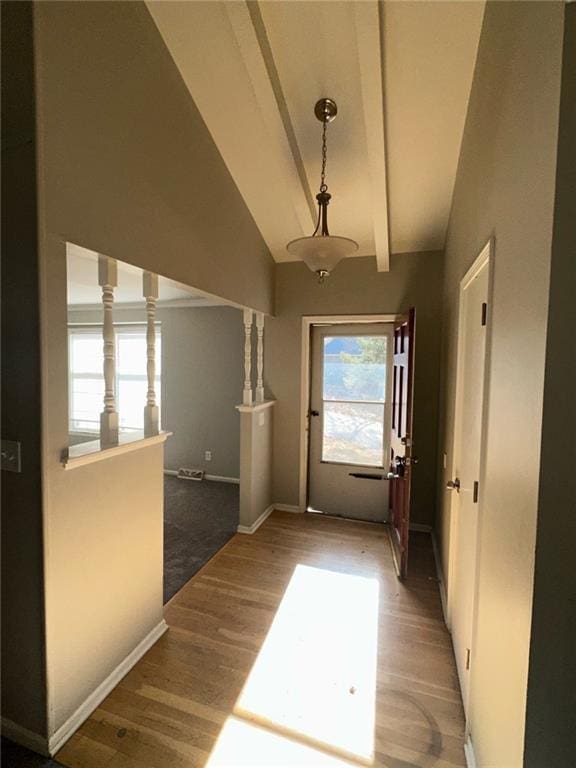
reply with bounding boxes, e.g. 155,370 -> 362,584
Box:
448,258 -> 489,709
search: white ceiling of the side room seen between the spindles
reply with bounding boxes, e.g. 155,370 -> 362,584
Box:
66,243 -> 225,309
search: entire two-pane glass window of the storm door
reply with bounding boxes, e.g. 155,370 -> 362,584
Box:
322,336 -> 387,467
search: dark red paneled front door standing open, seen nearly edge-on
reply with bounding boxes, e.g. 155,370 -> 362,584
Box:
390,309 -> 416,579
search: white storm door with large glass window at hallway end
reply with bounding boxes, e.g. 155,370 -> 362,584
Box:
308,323 -> 392,522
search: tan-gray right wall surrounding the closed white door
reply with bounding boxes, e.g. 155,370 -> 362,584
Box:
437,2 -> 564,766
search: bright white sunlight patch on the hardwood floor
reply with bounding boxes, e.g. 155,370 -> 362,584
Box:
223,565 -> 378,766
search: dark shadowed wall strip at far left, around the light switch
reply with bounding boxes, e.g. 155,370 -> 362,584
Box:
2,2 -> 46,735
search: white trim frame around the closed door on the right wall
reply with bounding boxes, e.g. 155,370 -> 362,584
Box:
443,237 -> 494,712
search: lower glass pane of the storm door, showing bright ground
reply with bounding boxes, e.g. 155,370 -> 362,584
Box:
322,401 -> 384,467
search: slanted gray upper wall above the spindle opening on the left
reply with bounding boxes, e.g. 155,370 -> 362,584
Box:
34,2 -> 274,312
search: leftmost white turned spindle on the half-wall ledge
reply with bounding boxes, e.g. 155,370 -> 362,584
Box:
98,256 -> 118,447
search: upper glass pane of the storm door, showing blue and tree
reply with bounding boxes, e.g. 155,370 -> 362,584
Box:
322,336 -> 386,403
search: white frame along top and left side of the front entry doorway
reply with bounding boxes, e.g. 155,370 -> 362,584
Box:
298,313 -> 402,512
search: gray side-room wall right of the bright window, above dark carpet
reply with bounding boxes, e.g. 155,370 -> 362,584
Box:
158,307 -> 244,477
